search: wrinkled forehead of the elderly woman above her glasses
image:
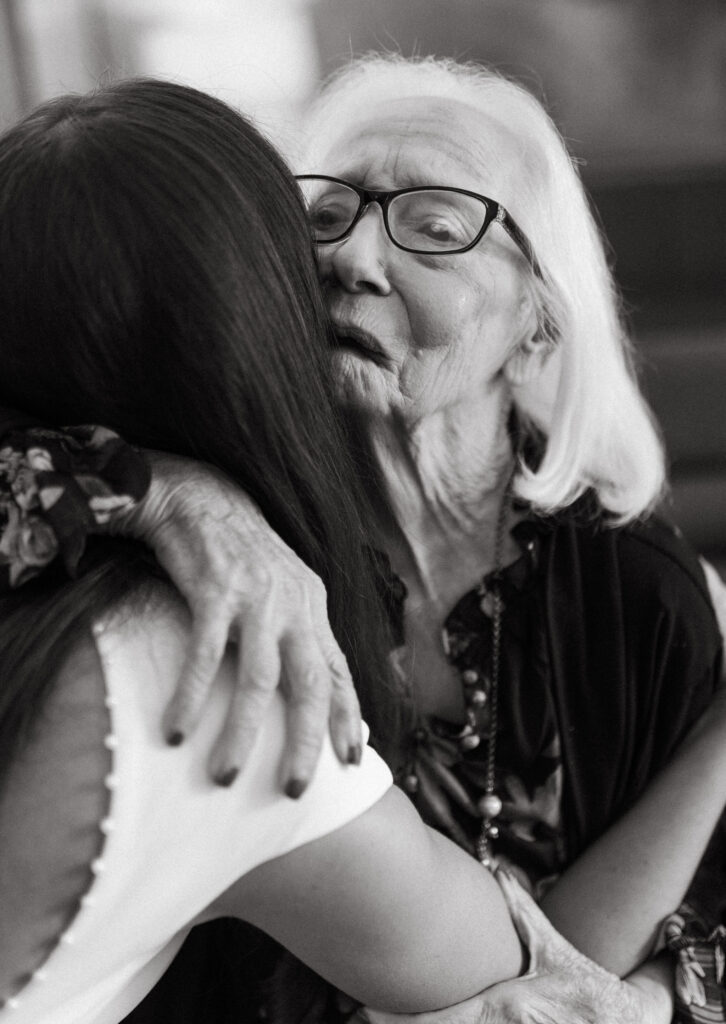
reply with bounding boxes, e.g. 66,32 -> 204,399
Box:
314,96 -> 523,204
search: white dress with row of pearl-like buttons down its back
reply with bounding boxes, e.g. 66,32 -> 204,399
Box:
0,602 -> 391,1024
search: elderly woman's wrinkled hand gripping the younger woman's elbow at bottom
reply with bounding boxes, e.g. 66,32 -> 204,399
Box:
361,871 -> 673,1024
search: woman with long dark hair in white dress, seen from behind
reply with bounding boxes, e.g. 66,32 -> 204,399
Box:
0,82 -> 532,1024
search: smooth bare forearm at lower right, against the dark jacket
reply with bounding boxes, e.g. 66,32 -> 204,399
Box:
542,689 -> 726,977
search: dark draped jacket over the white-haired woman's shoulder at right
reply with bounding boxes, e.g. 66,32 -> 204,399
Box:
539,507 -> 723,857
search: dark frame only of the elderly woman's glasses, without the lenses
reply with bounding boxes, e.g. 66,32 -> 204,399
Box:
295,174 -> 542,278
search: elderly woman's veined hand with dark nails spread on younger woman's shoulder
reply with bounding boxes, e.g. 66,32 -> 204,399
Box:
120,454 -> 361,797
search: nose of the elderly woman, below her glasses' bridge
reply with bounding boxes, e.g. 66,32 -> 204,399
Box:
318,203 -> 391,295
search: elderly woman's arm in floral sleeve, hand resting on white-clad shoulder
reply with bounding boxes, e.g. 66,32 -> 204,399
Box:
0,415 -> 361,796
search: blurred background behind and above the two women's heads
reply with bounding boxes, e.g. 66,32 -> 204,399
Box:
0,0 -> 726,570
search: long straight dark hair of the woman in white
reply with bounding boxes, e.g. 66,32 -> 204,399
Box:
0,80 -> 393,782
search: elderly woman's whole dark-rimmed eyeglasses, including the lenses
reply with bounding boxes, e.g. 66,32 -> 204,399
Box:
296,174 -> 540,276
